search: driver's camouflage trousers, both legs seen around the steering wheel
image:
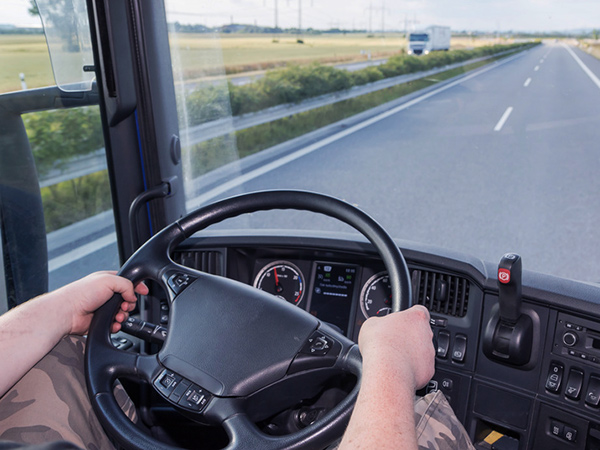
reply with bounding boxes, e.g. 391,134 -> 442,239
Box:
0,336 -> 474,450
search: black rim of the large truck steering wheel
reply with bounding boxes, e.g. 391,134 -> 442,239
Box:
85,191 -> 412,449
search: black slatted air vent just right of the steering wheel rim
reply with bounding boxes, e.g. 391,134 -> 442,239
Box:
412,270 -> 470,317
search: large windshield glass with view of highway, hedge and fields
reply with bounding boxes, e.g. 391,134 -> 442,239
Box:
166,0 -> 600,281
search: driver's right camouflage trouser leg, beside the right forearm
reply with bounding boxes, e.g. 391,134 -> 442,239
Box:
415,391 -> 475,450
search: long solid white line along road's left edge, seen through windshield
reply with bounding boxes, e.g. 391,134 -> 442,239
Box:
186,53 -> 523,211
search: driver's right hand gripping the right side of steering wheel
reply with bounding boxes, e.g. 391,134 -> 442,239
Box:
358,305 -> 435,390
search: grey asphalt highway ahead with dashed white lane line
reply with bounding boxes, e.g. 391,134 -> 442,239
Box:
52,44 -> 600,288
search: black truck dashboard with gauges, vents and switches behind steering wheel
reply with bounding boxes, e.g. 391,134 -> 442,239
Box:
151,232 -> 600,449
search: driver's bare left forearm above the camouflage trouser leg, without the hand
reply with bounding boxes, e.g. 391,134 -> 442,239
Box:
0,293 -> 70,396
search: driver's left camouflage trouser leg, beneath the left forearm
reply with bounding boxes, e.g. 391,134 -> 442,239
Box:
0,336 -> 137,450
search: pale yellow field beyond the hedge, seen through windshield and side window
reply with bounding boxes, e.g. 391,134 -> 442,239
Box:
0,33 -> 502,93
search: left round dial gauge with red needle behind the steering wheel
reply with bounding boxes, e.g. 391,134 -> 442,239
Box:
254,261 -> 304,305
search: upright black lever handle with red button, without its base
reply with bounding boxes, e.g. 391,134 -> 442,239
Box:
498,253 -> 523,325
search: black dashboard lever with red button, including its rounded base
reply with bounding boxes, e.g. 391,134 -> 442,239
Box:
483,253 -> 534,366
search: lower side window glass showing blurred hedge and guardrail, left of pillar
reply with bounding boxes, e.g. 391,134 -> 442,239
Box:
22,106 -> 118,290
